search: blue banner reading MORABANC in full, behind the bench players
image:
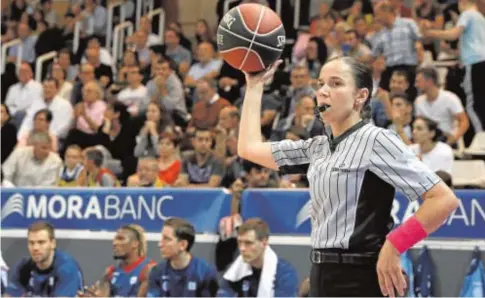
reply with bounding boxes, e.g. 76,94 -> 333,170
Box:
1,188 -> 231,233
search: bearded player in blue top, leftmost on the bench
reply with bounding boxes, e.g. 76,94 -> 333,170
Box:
5,222 -> 83,297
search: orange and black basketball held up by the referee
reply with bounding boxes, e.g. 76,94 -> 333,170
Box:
217,3 -> 286,73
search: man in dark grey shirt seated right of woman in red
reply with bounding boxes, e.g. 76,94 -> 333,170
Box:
174,128 -> 224,187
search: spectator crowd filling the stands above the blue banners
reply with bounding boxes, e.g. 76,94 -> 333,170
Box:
1,0 -> 485,207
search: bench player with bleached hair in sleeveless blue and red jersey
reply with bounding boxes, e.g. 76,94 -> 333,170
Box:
79,224 -> 156,297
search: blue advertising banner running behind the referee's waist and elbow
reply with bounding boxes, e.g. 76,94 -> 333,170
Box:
241,189 -> 485,239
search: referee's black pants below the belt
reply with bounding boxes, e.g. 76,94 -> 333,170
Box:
310,263 -> 382,297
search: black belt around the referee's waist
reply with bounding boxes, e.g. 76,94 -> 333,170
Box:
310,249 -> 377,265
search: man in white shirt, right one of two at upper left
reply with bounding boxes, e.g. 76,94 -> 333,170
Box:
17,78 -> 73,139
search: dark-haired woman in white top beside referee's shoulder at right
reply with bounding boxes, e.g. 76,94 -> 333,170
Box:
409,116 -> 454,175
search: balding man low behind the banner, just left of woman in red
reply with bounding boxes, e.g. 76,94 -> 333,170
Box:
126,157 -> 164,187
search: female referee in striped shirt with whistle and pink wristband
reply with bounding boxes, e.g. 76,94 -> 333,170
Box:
238,57 -> 458,297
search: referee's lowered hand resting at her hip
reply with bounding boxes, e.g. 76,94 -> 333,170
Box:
377,241 -> 407,297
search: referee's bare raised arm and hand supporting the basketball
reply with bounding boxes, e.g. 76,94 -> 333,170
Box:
237,60 -> 281,170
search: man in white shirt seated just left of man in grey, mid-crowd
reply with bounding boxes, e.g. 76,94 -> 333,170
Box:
118,66 -> 150,116
